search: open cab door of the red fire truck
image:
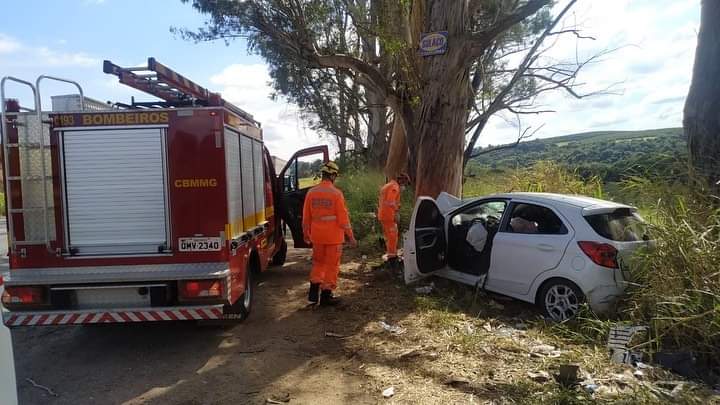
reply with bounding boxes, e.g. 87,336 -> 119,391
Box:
278,145 -> 330,248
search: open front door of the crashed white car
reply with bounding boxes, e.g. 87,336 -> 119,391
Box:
404,197 -> 447,283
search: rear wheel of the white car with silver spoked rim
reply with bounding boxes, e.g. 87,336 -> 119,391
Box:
537,279 -> 585,322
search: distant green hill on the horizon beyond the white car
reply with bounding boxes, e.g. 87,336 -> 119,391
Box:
468,128 -> 687,182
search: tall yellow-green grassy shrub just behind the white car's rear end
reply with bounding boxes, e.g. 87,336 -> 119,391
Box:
624,178 -> 720,364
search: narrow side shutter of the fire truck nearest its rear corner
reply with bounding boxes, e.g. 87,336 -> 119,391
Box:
225,130 -> 243,239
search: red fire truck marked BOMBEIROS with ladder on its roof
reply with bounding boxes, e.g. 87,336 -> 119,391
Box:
0,58 -> 328,326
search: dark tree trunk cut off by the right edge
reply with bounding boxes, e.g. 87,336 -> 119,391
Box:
683,0 -> 720,185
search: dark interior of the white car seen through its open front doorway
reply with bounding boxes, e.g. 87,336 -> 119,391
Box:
448,200 -> 507,275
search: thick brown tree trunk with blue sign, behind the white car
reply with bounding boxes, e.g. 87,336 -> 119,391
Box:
415,0 -> 471,197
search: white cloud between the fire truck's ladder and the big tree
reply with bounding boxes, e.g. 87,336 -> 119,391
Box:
210,64 -> 326,159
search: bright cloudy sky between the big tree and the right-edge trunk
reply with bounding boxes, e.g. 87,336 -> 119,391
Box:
480,0 -> 700,145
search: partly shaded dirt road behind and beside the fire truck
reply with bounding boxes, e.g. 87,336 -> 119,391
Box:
13,251 -> 378,405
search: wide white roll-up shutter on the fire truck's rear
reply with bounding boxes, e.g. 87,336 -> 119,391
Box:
63,128 -> 169,255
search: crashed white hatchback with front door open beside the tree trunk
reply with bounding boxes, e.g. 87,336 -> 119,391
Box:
404,193 -> 650,321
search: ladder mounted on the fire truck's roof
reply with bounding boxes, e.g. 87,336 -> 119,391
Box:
103,58 -> 260,126
